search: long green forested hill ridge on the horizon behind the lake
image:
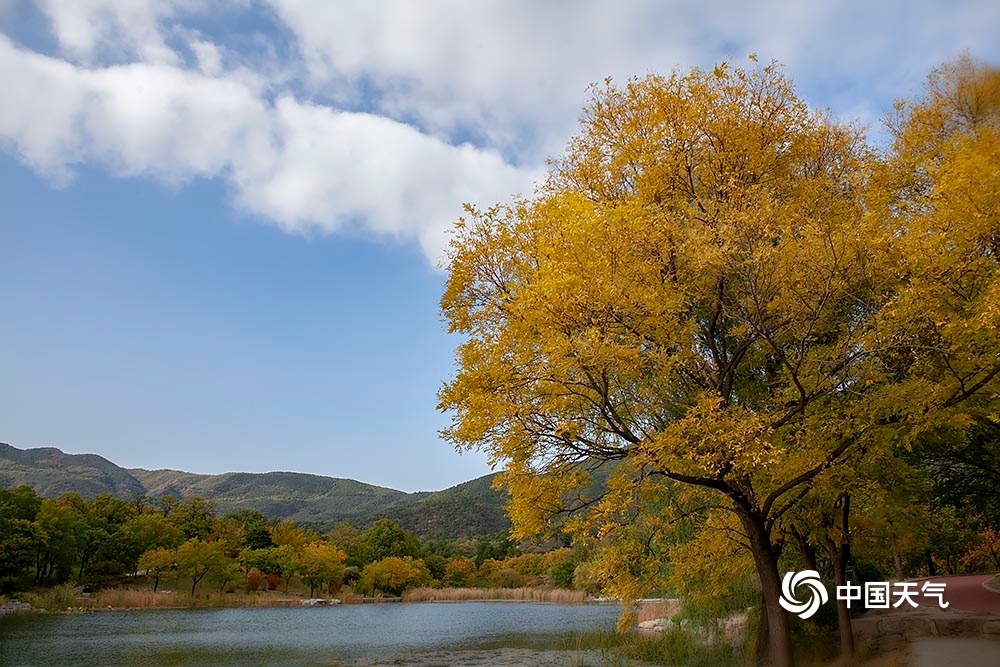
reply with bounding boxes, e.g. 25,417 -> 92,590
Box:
0,443 -> 510,539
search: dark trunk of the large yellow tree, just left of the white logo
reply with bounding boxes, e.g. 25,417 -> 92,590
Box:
736,505 -> 795,667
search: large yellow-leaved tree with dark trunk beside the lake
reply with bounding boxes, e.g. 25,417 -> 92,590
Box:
440,58 -> 996,665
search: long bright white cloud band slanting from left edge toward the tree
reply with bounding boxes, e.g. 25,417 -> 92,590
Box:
0,37 -> 536,261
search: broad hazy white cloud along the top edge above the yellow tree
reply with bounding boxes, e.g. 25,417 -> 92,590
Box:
268,0 -> 1000,162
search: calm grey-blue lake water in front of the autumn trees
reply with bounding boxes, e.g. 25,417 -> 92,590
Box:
0,602 -> 619,667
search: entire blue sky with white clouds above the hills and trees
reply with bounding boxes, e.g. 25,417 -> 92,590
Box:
0,0 -> 1000,490
